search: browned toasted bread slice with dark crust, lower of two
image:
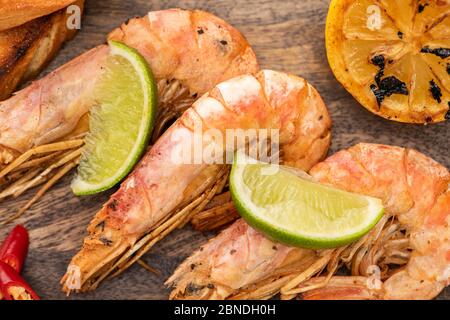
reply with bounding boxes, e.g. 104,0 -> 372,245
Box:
0,0 -> 83,101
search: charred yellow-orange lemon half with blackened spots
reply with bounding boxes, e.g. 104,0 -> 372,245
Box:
326,0 -> 450,123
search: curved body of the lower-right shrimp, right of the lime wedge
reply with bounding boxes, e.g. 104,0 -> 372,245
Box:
303,145 -> 450,300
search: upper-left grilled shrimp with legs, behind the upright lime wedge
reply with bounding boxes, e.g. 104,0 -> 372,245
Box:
0,9 -> 258,221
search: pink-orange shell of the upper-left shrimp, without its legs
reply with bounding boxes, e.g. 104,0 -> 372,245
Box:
0,9 -> 258,153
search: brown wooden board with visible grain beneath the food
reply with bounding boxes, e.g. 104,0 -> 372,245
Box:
0,0 -> 450,299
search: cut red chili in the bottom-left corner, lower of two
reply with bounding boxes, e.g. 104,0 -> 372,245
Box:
0,261 -> 40,300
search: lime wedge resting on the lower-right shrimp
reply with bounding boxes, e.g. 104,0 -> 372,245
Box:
230,154 -> 384,249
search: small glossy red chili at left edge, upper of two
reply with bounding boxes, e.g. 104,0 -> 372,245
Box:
0,225 -> 29,273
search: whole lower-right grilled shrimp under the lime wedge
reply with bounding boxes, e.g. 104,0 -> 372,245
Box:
167,144 -> 450,299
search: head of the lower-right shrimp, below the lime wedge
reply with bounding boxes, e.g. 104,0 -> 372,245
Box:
167,219 -> 325,300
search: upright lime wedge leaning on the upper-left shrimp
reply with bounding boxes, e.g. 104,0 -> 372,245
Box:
71,41 -> 158,195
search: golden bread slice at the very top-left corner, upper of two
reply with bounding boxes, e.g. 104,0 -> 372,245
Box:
0,0 -> 81,31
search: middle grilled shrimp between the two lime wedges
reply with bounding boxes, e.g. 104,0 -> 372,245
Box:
62,70 -> 331,292
